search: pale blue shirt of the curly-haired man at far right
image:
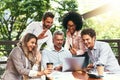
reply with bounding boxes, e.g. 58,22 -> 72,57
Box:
88,41 -> 120,73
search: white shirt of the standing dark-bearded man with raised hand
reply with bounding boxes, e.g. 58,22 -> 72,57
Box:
23,22 -> 53,50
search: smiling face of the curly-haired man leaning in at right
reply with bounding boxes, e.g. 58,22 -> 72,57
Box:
82,34 -> 95,50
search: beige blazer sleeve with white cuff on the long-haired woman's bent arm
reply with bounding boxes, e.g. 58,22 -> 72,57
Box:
11,49 -> 41,77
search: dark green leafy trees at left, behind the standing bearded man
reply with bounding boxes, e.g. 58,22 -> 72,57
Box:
0,0 -> 50,40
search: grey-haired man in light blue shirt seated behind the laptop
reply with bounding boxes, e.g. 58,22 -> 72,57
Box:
42,31 -> 72,71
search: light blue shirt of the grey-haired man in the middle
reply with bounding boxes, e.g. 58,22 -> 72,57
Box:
42,47 -> 72,68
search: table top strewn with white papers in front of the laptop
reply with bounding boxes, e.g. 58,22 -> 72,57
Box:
46,71 -> 120,80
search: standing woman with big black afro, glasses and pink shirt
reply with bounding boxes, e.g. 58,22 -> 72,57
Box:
62,11 -> 85,56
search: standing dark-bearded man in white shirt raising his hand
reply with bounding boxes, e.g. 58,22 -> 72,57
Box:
23,12 -> 54,50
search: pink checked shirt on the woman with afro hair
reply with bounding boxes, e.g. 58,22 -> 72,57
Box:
64,31 -> 85,55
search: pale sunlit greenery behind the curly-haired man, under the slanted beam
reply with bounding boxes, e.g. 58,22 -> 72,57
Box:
84,12 -> 120,39
